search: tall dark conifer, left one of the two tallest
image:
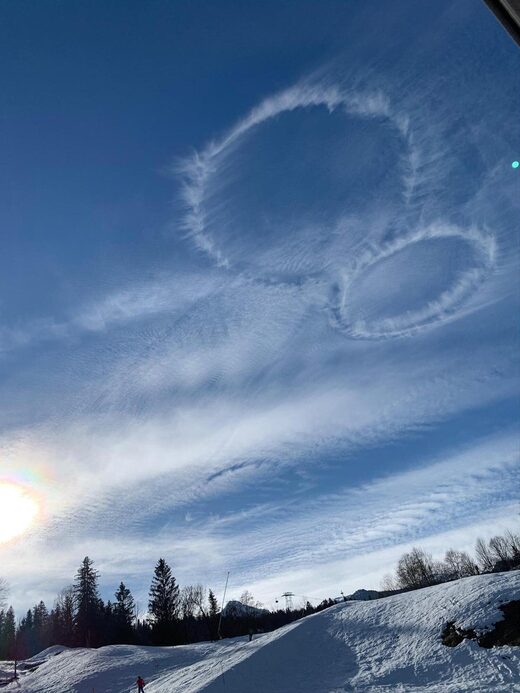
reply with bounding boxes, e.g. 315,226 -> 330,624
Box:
74,556 -> 102,647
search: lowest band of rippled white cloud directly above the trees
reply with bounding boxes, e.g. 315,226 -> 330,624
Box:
3,431 -> 520,602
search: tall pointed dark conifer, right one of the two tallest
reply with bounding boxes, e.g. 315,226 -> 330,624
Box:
148,558 -> 179,644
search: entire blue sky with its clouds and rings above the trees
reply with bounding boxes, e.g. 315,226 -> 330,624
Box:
0,0 -> 520,608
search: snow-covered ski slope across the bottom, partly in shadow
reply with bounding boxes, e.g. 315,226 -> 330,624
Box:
4,571 -> 520,693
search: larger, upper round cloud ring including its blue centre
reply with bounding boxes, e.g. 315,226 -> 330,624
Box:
183,86 -> 411,281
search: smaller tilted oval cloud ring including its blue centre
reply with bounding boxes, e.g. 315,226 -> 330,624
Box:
330,225 -> 496,339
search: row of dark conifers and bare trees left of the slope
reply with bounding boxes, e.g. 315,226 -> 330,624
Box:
0,556 -> 333,660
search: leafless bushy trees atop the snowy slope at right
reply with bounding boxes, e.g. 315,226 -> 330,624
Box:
382,530 -> 520,592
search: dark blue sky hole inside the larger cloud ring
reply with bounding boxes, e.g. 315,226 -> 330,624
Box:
197,100 -> 406,279
